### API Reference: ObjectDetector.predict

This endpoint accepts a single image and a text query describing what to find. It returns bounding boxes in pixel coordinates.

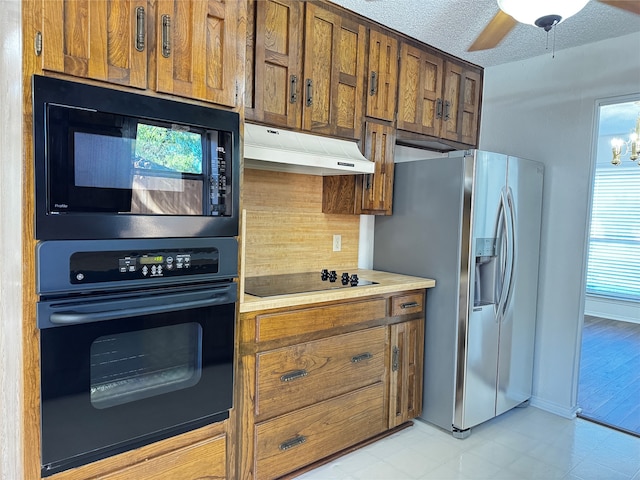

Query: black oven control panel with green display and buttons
[69,247,219,284]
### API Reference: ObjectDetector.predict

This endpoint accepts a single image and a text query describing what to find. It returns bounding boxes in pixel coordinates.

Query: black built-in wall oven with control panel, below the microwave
[37,238,238,476]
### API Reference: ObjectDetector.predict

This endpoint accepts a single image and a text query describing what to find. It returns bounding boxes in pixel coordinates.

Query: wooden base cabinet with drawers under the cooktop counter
[236,290,425,480]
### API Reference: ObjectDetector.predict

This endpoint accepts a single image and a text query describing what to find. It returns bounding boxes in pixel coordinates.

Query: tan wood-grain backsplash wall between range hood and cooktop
[241,169,360,276]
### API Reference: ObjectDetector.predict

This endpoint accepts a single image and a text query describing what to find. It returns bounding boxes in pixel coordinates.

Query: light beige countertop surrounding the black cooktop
[240,269,436,313]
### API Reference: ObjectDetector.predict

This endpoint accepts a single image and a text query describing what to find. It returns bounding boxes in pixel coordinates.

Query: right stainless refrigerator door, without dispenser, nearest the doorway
[496,157,543,415]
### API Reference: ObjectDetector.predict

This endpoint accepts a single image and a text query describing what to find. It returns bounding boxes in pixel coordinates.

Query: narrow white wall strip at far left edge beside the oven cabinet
[0,0,23,480]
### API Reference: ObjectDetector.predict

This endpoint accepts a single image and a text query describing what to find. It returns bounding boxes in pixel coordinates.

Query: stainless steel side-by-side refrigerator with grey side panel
[373,150,543,438]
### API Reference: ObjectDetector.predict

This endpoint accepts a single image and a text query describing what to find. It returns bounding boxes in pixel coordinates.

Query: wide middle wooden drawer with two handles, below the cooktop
[256,327,386,418]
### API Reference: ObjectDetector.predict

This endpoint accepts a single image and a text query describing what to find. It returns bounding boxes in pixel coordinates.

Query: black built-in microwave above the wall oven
[33,75,240,240]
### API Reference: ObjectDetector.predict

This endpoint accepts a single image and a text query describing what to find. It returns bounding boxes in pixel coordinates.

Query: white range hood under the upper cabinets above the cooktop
[244,123,374,175]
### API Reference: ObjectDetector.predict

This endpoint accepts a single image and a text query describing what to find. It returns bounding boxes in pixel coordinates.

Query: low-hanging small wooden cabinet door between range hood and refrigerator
[356,121,396,215]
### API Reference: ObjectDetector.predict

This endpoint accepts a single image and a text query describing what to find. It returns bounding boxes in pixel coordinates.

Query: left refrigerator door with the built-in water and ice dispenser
[454,151,507,430]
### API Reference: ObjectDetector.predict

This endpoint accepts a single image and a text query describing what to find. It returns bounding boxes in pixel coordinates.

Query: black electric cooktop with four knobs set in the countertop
[244,270,377,297]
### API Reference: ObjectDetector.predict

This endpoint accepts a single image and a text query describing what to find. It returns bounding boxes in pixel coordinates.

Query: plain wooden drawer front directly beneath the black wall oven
[100,434,227,480]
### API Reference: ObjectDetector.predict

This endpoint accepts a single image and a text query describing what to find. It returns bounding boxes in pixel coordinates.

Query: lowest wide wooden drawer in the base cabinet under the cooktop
[255,382,386,479]
